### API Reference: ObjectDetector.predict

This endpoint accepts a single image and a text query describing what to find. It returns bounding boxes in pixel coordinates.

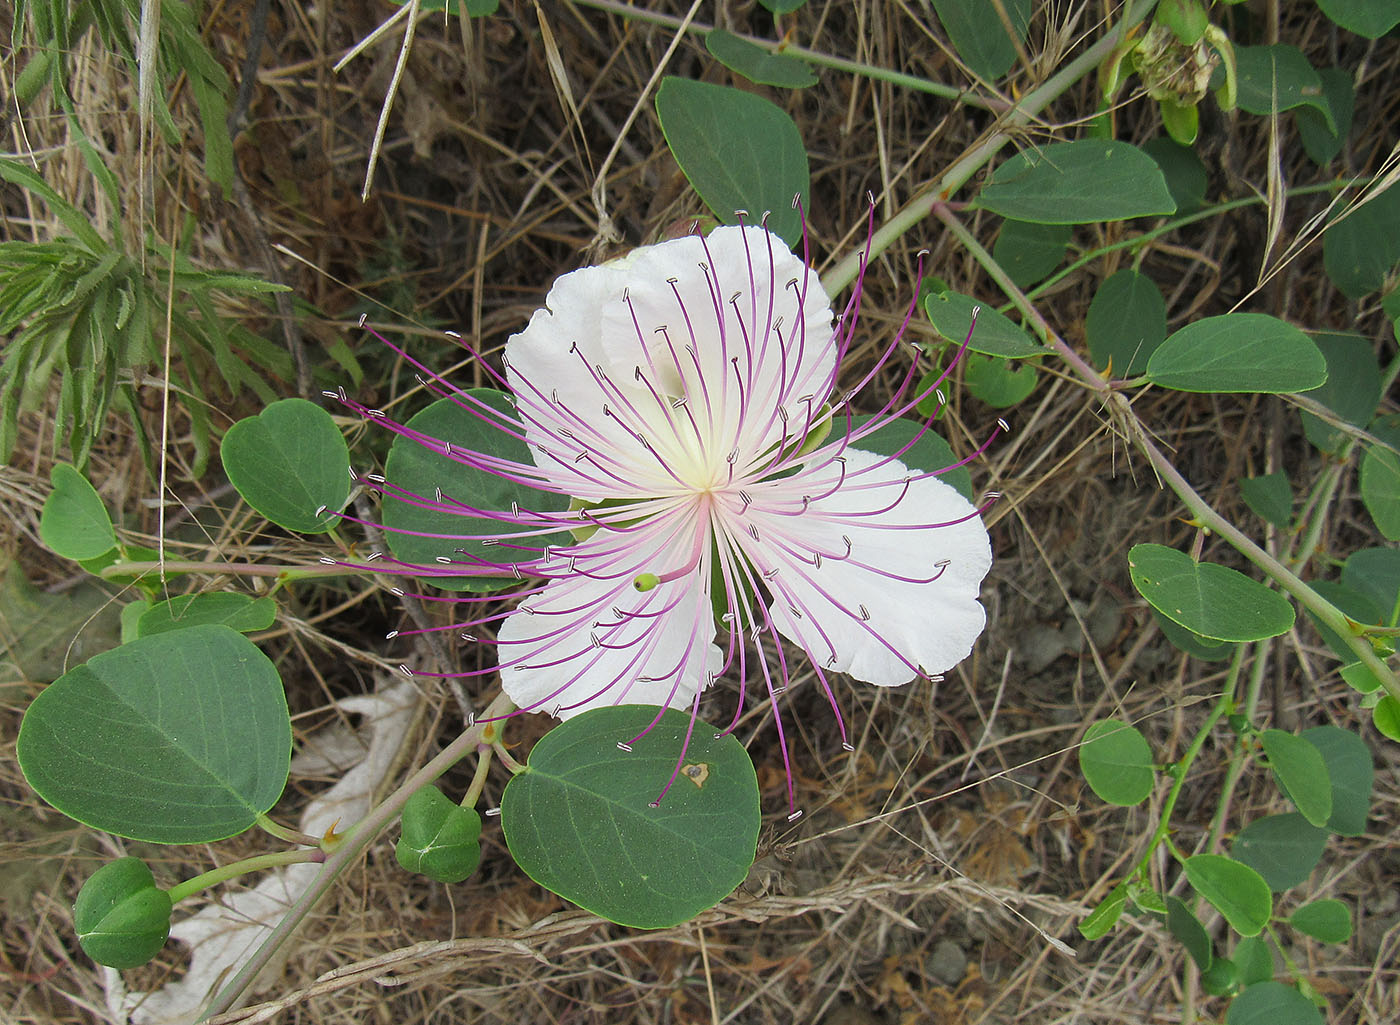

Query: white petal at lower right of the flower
[735,449,991,686]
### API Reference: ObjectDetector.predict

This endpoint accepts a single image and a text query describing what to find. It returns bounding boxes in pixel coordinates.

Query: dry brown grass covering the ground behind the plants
[0,0,1400,1025]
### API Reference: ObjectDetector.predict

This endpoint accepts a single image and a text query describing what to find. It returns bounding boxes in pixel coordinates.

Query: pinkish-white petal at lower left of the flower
[497,509,722,718]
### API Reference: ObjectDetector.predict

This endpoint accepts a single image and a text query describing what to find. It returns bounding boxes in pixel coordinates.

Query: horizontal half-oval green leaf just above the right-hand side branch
[1147,314,1327,395]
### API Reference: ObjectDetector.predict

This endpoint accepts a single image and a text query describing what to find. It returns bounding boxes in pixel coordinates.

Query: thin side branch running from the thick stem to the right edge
[930,203,1400,702]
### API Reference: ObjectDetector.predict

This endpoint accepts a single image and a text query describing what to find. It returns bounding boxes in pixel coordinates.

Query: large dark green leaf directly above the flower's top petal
[657,76,811,245]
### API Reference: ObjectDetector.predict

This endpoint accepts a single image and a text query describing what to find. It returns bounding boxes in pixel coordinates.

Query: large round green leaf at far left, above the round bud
[17,626,291,843]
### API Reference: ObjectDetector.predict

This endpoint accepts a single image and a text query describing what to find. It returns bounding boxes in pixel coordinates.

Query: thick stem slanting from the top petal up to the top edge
[817,0,1156,295]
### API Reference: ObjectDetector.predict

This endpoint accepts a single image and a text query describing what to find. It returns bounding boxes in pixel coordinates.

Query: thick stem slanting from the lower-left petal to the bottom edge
[199,693,514,1021]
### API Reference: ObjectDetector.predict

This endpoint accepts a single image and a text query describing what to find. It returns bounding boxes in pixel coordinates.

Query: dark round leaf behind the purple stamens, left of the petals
[382,388,573,591]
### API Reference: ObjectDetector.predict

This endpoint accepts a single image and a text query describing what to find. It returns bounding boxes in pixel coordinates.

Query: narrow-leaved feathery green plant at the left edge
[0,160,291,476]
